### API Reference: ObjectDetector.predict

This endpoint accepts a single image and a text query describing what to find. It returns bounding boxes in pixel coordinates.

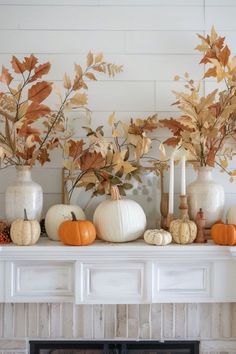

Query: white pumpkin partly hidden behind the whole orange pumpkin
[45,204,86,241]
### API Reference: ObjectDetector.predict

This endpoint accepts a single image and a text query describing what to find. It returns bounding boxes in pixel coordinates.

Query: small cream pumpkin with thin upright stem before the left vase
[10,209,41,246]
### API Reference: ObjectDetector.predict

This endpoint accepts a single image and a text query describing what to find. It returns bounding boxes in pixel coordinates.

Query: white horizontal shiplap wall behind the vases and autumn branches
[0,0,236,220]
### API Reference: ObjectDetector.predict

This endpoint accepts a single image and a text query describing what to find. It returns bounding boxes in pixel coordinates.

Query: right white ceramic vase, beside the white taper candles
[187,167,225,228]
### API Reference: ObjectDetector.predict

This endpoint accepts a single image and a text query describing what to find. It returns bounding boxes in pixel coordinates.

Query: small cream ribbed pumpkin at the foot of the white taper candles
[170,219,197,244]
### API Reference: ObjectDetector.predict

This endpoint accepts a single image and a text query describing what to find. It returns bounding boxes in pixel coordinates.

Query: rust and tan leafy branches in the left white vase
[0,52,122,166]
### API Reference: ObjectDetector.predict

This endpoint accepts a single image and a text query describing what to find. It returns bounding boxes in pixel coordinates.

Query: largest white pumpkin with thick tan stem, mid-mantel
[93,186,147,242]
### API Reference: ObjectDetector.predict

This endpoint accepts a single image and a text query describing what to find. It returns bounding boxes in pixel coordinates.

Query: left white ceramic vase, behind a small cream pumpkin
[5,166,43,223]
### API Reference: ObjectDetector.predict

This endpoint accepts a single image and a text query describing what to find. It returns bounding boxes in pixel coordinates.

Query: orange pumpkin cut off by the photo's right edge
[211,223,236,246]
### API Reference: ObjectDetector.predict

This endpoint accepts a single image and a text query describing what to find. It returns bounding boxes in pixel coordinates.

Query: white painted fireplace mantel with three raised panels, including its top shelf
[0,238,236,304]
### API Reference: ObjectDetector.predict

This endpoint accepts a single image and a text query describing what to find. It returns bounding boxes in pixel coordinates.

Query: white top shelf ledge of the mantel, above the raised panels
[0,237,233,261]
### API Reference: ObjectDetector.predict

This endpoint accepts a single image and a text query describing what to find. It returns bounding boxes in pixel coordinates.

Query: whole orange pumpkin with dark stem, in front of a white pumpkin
[58,212,96,246]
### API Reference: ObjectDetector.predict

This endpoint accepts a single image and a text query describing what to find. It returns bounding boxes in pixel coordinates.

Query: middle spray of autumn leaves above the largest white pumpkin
[64,113,167,200]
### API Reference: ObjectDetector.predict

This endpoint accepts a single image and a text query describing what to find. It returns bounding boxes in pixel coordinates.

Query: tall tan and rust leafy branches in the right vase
[161,27,236,180]
